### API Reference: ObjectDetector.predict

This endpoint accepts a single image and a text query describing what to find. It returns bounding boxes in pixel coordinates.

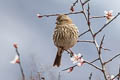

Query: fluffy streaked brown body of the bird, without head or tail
[53,24,78,50]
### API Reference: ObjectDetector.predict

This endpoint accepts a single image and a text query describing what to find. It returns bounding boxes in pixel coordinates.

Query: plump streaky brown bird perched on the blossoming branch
[53,14,79,67]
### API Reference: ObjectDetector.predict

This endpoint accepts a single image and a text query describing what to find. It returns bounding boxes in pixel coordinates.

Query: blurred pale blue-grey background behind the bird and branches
[0,0,120,80]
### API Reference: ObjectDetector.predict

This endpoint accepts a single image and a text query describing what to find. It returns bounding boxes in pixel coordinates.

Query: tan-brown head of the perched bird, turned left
[56,14,72,25]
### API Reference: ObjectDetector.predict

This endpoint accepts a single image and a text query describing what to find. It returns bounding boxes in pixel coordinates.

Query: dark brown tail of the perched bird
[53,48,64,67]
